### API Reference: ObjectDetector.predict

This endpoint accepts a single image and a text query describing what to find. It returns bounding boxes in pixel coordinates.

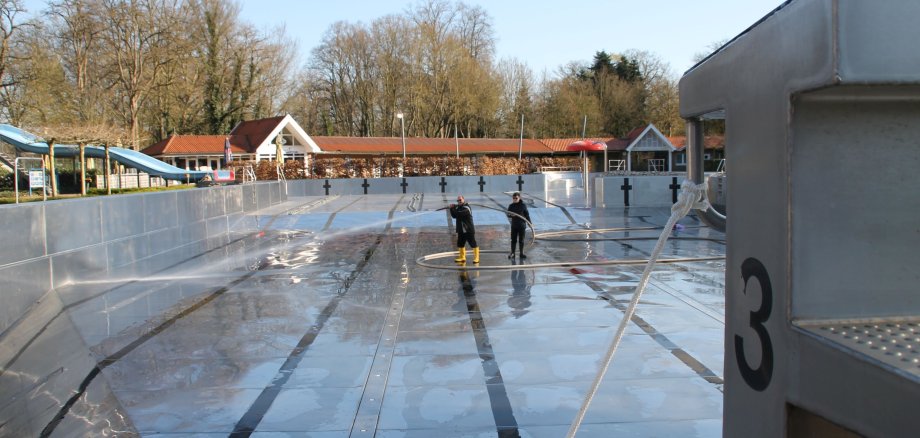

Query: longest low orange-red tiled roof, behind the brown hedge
[312,137,553,155]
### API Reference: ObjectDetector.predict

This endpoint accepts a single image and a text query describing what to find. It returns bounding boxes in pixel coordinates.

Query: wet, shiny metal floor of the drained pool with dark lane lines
[19,193,725,437]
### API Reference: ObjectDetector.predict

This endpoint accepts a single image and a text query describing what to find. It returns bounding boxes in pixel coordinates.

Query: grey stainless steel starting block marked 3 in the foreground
[680,0,920,437]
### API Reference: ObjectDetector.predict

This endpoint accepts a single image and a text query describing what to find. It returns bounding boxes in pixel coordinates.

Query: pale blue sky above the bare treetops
[242,0,783,78]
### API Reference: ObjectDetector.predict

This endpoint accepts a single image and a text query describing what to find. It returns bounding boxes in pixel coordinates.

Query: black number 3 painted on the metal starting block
[735,258,773,391]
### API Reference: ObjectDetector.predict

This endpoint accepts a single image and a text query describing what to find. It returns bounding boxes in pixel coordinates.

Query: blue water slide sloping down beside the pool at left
[0,124,210,181]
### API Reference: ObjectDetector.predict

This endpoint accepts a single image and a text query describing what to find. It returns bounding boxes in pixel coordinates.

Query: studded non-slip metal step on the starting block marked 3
[799,321,920,379]
